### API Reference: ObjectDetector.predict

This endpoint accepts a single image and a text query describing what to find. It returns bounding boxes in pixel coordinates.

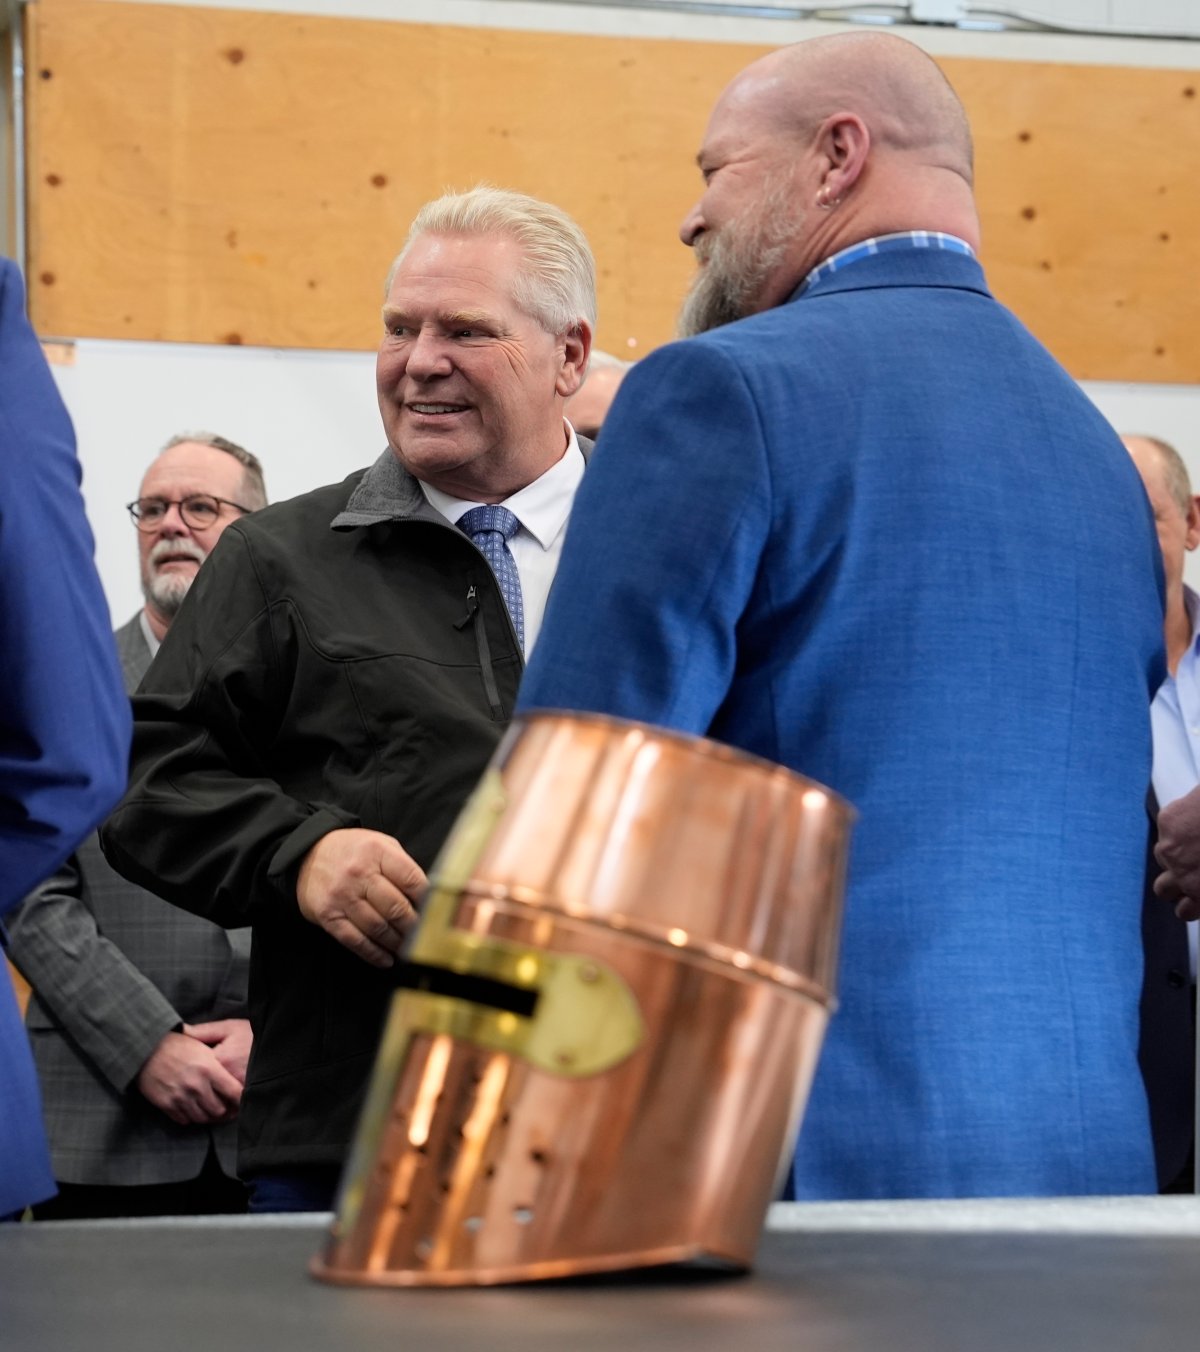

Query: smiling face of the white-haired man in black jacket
[376,234,588,503]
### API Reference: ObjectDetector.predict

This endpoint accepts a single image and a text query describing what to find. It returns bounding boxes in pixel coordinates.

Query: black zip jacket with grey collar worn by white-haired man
[103,452,523,1174]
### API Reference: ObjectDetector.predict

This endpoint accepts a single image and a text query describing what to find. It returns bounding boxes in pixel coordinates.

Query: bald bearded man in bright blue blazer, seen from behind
[520,32,1164,1198]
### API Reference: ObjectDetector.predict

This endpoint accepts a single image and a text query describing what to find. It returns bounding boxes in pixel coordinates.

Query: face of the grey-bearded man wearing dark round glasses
[138,441,246,638]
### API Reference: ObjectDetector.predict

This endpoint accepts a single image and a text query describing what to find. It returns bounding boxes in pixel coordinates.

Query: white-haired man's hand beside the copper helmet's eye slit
[296,826,427,967]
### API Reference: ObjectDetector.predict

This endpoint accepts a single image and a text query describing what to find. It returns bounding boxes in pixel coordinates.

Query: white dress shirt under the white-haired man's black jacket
[418,420,584,660]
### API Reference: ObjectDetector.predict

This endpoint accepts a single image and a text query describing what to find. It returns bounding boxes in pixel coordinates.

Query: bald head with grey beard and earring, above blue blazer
[680,32,978,334]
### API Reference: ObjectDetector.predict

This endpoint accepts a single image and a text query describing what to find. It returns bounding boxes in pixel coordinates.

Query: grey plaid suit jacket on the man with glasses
[9,617,250,1186]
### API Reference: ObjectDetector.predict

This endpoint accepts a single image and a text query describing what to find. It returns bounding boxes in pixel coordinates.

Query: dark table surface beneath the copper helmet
[0,1197,1200,1352]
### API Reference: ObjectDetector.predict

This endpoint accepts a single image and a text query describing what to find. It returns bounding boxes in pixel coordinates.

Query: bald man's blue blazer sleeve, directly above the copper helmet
[518,343,770,733]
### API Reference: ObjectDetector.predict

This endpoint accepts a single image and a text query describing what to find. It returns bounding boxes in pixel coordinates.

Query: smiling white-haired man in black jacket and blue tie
[104,188,596,1211]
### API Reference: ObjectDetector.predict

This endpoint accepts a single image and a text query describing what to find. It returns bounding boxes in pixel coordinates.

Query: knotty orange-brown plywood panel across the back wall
[27,0,1200,383]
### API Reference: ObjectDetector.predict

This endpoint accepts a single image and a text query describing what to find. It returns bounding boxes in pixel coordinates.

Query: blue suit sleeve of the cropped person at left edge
[0,260,130,914]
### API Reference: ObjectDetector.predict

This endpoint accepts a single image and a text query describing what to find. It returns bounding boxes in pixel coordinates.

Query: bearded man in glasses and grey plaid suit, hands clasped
[9,433,266,1220]
